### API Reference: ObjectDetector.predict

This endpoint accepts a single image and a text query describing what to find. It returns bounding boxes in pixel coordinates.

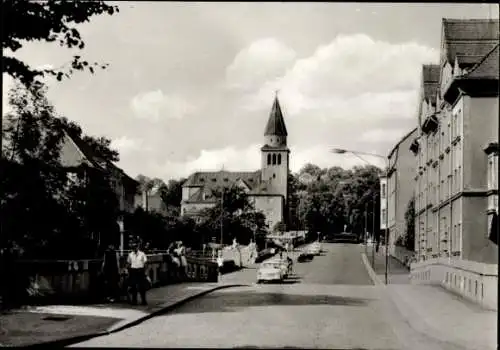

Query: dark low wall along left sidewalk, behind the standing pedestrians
[15,254,217,302]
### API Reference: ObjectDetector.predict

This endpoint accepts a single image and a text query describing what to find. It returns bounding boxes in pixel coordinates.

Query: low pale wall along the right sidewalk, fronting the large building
[410,258,498,310]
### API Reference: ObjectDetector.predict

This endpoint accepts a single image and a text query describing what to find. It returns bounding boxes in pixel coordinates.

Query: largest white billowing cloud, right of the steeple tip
[232,34,438,122]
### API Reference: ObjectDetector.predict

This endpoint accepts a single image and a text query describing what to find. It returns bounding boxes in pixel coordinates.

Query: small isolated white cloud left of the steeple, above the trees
[130,90,195,122]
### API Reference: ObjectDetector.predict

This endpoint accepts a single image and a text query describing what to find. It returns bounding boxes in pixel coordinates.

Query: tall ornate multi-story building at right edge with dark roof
[412,19,499,308]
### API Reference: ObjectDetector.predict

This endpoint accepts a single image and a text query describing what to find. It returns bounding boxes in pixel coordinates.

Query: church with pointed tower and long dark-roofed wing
[181,96,290,230]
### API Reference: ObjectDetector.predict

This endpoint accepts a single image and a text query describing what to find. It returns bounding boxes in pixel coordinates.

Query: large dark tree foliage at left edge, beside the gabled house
[0,84,122,258]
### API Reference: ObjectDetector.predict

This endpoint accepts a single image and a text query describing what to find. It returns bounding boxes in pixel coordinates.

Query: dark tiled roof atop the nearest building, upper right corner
[443,18,499,66]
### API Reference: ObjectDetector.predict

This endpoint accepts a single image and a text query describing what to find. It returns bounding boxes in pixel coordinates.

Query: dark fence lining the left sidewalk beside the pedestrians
[2,254,217,303]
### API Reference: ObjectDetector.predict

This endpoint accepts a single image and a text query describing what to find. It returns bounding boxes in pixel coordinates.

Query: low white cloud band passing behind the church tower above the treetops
[151,144,384,179]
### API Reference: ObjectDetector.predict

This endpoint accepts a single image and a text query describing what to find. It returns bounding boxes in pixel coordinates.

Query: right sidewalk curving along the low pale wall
[367,249,497,350]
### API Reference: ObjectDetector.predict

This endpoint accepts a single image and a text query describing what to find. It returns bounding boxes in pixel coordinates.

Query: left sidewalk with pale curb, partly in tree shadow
[0,283,240,346]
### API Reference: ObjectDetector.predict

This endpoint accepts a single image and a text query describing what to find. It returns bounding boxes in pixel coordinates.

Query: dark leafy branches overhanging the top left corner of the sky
[2,0,118,86]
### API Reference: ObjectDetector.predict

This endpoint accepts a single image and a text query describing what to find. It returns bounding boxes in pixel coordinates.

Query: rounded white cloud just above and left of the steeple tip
[226,38,296,90]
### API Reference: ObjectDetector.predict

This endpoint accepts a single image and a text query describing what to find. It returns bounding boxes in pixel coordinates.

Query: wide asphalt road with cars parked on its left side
[72,244,462,350]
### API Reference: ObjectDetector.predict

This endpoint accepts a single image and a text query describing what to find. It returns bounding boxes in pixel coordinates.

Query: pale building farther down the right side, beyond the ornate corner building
[381,128,417,253]
